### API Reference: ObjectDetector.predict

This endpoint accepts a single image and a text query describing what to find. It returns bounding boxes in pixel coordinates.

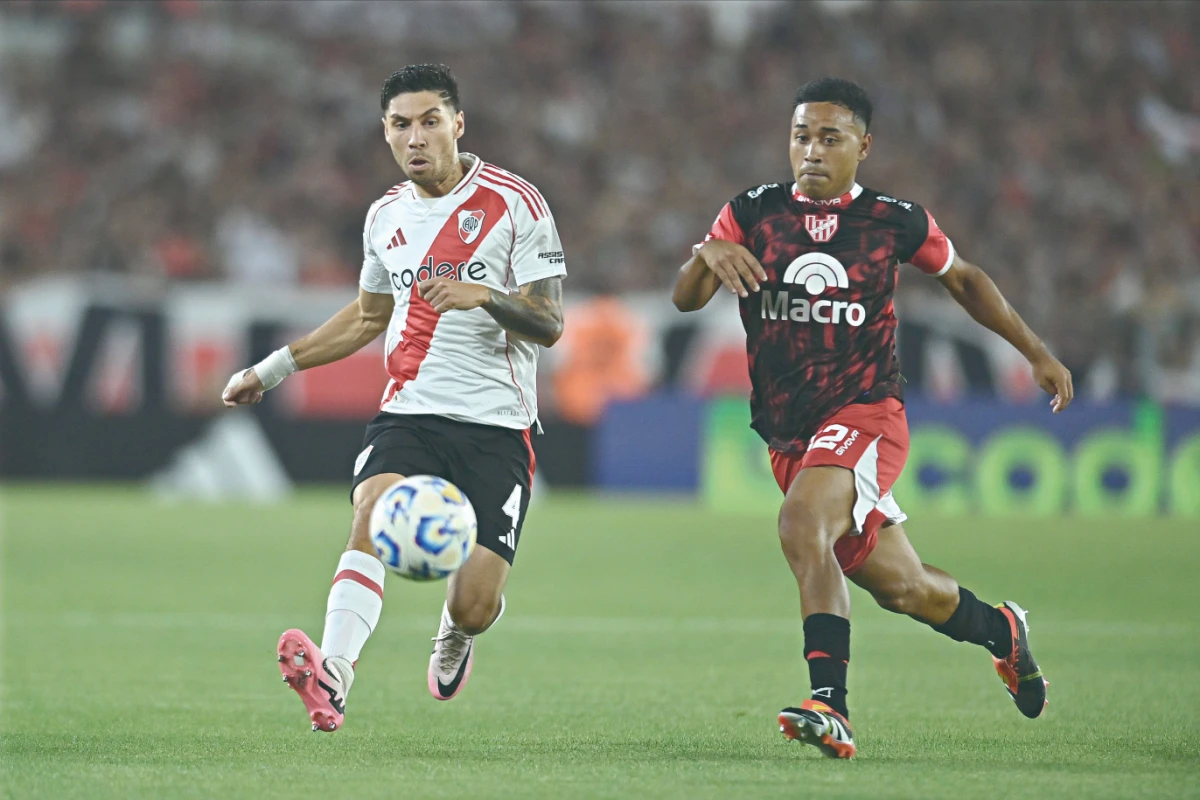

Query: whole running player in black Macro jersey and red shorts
[674,78,1074,758]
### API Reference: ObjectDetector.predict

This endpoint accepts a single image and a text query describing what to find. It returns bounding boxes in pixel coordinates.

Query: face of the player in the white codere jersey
[383,91,463,186]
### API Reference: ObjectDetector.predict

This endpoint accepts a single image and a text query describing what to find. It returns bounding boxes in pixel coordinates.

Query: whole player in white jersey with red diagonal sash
[222,65,566,730]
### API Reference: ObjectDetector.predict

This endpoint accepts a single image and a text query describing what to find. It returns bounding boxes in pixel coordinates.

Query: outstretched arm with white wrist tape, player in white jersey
[221,288,395,408]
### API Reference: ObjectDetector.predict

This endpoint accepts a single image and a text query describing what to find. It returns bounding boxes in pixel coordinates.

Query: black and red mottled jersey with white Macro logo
[704,181,954,452]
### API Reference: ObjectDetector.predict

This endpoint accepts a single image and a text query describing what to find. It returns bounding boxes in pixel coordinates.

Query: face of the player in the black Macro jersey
[790,103,871,200]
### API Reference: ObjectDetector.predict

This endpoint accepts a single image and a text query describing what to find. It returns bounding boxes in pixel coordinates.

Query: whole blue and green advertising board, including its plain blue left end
[593,395,1200,518]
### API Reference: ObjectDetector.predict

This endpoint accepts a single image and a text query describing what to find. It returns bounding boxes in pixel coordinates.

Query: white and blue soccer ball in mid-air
[371,475,476,581]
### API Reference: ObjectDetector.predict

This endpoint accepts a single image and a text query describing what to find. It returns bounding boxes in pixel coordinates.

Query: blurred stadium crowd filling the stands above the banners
[0,0,1200,402]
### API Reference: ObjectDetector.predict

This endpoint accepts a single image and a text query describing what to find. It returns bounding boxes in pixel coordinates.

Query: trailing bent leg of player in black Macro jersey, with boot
[851,524,1048,718]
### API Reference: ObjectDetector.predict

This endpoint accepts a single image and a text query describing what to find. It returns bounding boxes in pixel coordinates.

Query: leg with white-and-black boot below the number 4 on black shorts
[428,546,511,700]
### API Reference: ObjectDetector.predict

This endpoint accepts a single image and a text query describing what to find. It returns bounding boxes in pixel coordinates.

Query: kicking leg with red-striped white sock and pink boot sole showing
[277,473,401,732]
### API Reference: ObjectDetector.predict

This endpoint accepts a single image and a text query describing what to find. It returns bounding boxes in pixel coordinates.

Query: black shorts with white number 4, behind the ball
[350,411,538,564]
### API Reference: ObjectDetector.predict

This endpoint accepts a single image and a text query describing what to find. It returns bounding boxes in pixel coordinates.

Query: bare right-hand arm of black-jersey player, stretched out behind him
[938,255,1075,414]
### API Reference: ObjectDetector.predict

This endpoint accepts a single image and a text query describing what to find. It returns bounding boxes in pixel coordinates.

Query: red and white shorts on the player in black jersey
[770,397,908,575]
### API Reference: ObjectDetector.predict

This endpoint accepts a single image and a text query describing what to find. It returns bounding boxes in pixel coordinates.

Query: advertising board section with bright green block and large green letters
[702,399,1200,517]
